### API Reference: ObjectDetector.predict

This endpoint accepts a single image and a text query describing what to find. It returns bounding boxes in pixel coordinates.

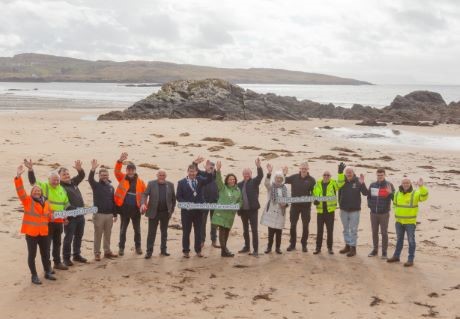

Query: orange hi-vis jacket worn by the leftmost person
[14,177,51,237]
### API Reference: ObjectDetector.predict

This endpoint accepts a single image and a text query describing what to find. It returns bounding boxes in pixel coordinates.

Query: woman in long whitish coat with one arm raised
[260,163,288,254]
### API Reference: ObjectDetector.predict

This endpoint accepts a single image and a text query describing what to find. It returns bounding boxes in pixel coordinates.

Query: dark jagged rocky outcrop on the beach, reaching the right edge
[98,79,460,125]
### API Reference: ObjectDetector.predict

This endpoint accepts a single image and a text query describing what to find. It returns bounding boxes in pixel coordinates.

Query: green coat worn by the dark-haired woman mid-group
[211,172,243,229]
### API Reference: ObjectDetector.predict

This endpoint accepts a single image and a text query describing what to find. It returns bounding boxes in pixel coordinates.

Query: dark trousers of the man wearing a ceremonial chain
[181,209,203,253]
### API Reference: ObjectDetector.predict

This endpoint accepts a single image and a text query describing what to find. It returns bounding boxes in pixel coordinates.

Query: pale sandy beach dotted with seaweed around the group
[0,110,460,318]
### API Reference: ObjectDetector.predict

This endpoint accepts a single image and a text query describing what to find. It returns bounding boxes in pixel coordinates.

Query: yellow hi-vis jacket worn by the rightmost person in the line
[393,186,428,224]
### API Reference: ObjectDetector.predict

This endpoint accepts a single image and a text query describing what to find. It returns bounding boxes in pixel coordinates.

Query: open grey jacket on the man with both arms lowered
[141,180,176,218]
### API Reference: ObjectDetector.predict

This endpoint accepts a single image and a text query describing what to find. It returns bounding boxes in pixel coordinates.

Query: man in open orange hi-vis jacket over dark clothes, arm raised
[114,152,145,256]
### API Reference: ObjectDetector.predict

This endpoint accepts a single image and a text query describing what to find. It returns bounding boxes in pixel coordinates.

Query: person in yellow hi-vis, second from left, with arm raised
[24,159,69,270]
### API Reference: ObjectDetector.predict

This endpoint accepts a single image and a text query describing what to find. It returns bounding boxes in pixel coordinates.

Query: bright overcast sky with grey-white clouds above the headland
[0,0,460,84]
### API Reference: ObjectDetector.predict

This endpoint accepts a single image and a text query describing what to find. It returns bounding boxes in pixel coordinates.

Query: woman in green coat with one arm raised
[212,161,243,257]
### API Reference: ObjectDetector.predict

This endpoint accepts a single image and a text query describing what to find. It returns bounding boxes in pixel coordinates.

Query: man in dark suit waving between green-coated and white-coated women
[238,158,264,257]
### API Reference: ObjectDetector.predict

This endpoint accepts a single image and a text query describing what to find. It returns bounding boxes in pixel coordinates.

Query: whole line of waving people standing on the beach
[14,153,428,284]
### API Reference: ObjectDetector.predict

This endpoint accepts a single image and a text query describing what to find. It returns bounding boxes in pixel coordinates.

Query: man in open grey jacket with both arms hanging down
[141,169,176,259]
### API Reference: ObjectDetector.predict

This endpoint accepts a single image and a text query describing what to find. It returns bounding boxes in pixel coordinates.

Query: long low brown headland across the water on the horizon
[0,53,371,85]
